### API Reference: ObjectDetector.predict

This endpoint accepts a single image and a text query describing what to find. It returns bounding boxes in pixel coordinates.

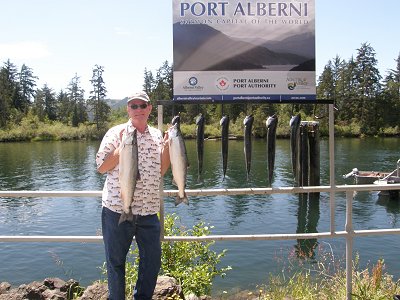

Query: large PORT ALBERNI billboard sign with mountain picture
[173,0,316,102]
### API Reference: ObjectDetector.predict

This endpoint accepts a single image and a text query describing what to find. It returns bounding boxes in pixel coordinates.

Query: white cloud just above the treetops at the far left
[0,42,51,60]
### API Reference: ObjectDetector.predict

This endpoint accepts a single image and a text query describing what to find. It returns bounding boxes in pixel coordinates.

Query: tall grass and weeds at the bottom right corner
[258,249,400,300]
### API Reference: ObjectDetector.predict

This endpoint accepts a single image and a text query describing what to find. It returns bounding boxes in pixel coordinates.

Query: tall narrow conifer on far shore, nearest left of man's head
[89,65,111,129]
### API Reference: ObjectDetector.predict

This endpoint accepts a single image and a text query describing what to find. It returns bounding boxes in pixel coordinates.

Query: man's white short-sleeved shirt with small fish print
[96,120,163,216]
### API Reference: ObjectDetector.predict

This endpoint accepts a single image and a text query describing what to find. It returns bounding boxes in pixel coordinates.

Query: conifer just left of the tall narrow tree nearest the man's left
[67,74,88,127]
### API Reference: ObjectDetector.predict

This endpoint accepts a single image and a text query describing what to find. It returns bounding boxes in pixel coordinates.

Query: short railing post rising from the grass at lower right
[346,191,354,300]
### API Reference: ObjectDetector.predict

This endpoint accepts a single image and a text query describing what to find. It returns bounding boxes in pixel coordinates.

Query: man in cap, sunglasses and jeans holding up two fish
[96,92,170,300]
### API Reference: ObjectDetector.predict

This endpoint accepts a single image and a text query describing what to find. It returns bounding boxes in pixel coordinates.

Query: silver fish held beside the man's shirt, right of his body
[168,124,189,205]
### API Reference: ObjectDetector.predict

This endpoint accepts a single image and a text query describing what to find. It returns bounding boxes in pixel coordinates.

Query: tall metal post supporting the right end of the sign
[329,104,335,234]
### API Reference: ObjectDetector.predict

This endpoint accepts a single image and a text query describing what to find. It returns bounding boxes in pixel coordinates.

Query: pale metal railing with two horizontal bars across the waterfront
[0,105,400,300]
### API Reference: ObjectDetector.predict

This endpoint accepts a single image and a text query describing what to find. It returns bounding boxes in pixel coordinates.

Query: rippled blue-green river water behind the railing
[0,138,400,293]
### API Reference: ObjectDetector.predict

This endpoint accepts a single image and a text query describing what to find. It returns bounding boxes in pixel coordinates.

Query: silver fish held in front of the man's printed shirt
[118,129,140,225]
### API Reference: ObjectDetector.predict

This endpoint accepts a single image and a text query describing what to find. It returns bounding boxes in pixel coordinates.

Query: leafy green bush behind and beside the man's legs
[102,214,231,297]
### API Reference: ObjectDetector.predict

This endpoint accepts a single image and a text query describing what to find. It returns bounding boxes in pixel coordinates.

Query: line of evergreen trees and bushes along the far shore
[0,43,400,140]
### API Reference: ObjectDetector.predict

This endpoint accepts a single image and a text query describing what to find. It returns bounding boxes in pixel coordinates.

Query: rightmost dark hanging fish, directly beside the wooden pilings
[289,114,301,186]
